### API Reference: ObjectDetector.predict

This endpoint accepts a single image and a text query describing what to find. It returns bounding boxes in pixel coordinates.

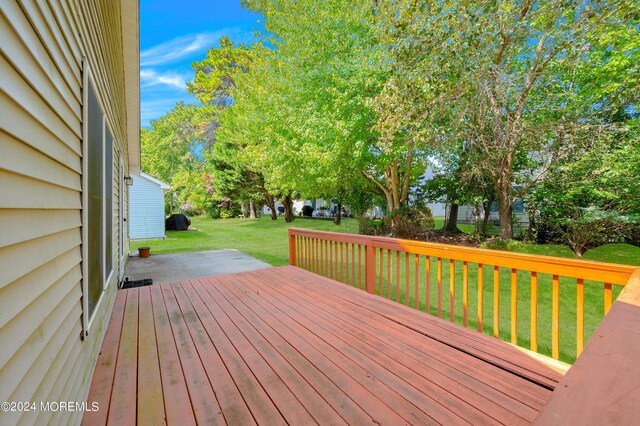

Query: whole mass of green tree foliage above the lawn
[143,0,640,246]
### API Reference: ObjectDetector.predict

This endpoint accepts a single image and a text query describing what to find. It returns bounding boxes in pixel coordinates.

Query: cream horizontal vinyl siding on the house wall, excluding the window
[0,0,131,425]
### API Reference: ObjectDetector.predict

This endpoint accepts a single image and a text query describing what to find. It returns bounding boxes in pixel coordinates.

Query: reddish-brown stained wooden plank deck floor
[83,266,562,425]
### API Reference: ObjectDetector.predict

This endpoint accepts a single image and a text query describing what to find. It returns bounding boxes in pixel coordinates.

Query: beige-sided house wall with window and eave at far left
[0,0,140,424]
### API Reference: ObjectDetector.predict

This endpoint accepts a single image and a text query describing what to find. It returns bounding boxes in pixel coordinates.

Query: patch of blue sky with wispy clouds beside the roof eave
[140,0,261,127]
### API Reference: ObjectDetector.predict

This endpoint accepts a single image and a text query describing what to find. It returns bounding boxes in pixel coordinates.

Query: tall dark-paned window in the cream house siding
[82,68,114,335]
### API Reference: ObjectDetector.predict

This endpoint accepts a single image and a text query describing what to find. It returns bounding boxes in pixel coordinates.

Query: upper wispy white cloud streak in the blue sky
[140,28,253,67]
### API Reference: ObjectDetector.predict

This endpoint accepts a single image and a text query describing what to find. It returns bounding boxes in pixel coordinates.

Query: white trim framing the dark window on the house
[81,58,115,339]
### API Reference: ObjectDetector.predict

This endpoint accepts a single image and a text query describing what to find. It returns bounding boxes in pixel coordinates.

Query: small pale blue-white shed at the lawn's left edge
[129,173,171,240]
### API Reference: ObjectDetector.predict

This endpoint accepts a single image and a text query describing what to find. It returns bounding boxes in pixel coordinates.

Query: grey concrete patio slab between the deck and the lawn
[124,250,271,284]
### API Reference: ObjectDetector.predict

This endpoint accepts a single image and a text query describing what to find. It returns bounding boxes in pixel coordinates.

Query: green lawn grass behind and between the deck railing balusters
[131,217,640,362]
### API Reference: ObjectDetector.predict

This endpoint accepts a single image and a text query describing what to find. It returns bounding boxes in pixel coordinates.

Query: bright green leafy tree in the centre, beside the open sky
[235,0,440,216]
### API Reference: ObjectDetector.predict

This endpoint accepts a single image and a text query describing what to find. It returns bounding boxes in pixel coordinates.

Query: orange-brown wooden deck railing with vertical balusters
[289,228,636,362]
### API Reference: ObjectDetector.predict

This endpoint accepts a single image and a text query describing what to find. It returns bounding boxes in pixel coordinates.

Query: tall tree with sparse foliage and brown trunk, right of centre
[370,0,638,238]
